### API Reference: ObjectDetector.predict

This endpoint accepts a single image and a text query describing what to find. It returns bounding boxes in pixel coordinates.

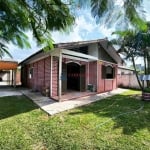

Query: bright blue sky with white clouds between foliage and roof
[5,0,150,63]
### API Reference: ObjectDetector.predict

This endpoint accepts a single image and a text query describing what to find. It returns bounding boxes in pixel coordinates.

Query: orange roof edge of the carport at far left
[0,60,18,70]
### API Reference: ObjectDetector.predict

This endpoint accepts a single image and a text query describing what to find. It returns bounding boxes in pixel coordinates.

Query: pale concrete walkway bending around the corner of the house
[22,88,127,115]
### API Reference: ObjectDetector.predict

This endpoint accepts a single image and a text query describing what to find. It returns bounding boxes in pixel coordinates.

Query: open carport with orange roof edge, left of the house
[0,60,18,87]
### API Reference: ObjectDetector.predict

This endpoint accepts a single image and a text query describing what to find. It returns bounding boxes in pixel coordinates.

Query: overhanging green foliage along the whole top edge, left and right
[0,0,147,57]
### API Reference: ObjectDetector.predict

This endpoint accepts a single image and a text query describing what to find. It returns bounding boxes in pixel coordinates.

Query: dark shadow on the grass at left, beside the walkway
[0,96,38,120]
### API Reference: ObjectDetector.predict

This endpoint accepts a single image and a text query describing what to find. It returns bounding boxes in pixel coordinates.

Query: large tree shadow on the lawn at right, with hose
[69,95,150,135]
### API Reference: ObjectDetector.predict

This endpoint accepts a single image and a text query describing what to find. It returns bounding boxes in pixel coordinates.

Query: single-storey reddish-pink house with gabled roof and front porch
[20,39,122,101]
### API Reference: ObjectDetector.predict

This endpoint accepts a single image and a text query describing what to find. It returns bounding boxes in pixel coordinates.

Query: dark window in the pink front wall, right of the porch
[102,65,115,79]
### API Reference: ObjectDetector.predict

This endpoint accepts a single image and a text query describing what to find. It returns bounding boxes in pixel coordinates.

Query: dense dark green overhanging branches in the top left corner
[0,0,74,57]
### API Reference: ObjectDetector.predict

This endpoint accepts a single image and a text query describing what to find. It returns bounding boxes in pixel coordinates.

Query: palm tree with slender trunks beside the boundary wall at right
[112,23,150,89]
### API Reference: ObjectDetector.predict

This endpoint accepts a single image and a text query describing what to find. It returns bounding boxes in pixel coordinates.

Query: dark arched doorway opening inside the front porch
[67,62,80,91]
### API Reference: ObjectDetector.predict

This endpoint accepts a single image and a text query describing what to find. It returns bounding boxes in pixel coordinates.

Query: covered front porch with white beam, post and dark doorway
[50,49,98,101]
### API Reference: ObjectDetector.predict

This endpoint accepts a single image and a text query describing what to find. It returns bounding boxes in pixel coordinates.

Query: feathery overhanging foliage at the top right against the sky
[78,0,147,30]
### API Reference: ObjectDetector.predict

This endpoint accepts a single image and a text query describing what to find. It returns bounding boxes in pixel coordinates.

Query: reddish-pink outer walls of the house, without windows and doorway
[22,56,117,97]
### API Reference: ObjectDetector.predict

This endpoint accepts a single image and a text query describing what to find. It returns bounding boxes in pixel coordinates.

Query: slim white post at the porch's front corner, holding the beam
[58,51,62,102]
